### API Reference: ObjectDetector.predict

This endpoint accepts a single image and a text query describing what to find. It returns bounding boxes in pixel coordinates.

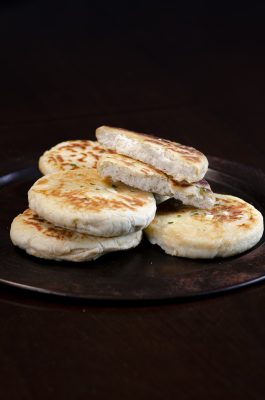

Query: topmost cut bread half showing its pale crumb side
[96,126,208,183]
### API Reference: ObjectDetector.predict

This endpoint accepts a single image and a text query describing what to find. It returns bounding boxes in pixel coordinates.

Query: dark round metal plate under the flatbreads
[0,157,265,300]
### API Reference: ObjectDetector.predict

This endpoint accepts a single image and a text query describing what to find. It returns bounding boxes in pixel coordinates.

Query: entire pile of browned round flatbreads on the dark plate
[11,126,263,261]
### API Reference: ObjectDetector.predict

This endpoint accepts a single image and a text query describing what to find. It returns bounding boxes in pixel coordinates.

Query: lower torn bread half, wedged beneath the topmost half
[97,153,215,209]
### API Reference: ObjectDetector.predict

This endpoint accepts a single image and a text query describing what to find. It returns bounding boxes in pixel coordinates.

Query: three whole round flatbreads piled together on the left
[11,140,156,261]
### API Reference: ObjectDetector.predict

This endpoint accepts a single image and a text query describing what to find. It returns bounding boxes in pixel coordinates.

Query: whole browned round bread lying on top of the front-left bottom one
[28,169,156,237]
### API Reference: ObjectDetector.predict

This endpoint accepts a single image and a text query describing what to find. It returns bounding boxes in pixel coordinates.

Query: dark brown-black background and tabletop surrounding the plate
[0,1,265,400]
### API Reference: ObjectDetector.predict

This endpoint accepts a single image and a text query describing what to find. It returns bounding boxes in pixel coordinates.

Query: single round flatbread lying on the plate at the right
[145,194,263,258]
